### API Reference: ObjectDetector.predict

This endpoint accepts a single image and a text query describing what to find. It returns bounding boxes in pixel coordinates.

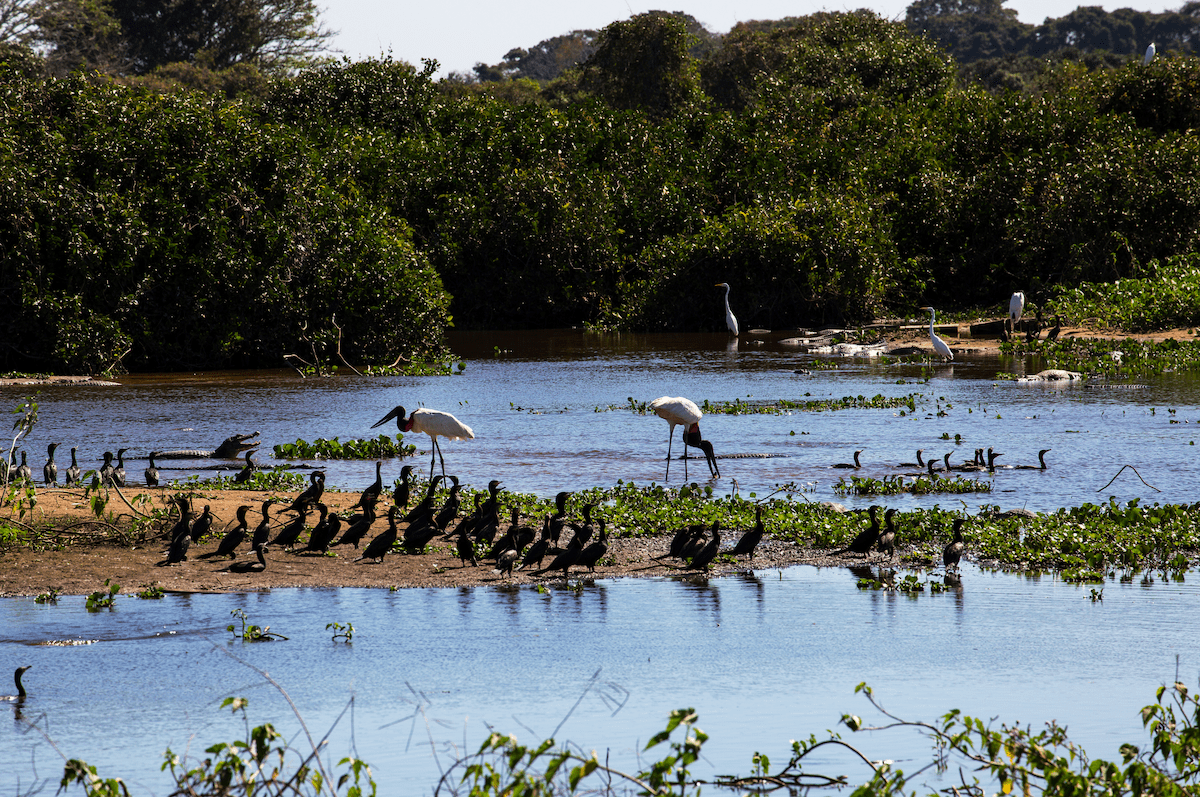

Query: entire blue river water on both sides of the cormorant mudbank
[0,331,1200,795]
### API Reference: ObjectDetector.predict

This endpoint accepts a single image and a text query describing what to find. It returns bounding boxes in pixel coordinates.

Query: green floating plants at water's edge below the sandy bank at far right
[1000,337,1200,378]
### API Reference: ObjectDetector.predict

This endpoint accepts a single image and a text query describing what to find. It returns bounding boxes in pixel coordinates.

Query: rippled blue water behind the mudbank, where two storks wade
[0,330,1200,510]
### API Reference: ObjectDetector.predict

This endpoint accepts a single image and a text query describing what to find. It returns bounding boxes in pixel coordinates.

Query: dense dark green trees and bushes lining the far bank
[0,0,1200,372]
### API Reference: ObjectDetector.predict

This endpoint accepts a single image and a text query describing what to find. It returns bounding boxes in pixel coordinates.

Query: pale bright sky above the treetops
[318,0,1184,76]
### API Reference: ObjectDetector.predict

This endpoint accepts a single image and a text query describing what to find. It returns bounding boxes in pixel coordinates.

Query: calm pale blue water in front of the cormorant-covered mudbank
[0,568,1200,793]
